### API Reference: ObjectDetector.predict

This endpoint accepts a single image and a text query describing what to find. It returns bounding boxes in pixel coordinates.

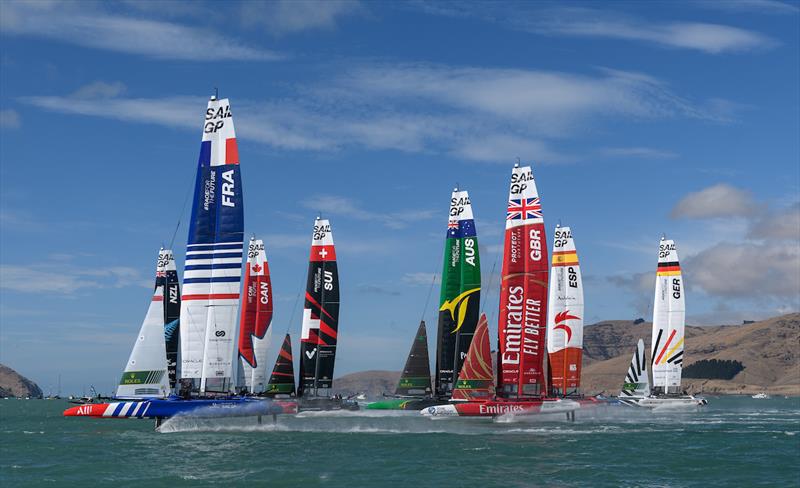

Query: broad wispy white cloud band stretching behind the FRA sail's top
[21,64,728,163]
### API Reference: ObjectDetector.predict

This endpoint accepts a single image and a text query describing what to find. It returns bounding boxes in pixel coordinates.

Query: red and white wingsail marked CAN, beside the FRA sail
[239,239,272,393]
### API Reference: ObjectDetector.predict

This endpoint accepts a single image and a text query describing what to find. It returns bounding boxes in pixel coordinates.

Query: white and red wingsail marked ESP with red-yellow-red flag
[547,225,583,396]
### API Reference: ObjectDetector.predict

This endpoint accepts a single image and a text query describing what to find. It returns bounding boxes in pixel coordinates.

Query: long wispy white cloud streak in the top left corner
[0,1,281,61]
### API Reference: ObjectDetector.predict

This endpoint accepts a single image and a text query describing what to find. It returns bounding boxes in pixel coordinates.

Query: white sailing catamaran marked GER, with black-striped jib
[620,237,708,408]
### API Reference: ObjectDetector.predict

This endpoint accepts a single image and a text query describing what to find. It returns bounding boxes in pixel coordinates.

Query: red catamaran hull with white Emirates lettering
[419,398,581,417]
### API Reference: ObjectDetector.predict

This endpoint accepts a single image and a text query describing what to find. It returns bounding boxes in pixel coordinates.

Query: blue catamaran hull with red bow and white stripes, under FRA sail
[64,398,296,419]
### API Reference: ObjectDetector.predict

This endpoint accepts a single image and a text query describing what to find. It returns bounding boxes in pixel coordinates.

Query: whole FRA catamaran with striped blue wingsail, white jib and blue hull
[64,96,284,425]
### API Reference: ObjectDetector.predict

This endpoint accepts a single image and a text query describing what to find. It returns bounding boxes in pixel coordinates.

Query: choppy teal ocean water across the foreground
[0,397,800,488]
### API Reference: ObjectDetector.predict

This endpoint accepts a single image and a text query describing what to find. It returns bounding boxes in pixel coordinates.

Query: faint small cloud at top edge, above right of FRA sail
[241,0,364,35]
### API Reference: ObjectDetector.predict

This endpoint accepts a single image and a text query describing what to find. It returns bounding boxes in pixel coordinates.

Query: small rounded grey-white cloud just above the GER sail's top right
[671,183,759,219]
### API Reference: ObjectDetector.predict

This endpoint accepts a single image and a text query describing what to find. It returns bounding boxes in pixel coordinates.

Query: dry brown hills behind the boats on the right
[334,313,800,397]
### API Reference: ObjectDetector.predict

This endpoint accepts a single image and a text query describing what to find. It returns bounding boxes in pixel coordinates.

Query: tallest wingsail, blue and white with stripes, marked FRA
[180,97,243,392]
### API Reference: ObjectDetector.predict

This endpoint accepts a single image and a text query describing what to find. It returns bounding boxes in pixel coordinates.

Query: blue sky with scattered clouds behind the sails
[0,0,800,393]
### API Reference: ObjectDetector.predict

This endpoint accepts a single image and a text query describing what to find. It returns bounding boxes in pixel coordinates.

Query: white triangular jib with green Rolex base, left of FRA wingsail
[117,252,169,398]
